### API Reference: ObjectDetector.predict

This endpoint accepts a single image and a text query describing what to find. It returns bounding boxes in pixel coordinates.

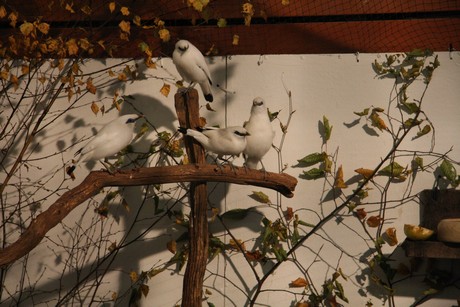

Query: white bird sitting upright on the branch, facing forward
[243,97,275,169]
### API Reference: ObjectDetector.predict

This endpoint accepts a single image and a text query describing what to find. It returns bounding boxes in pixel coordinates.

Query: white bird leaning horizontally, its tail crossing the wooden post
[179,126,249,159]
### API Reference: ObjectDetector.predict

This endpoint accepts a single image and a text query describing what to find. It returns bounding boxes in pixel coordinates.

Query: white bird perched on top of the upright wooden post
[172,40,213,102]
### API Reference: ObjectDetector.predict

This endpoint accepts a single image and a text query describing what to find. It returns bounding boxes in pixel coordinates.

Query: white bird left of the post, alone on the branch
[67,114,143,176]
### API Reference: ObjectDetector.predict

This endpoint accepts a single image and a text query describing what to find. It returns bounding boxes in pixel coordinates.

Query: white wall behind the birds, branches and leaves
[3,53,460,306]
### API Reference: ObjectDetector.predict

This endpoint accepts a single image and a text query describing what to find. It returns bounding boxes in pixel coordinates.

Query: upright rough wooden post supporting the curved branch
[174,89,208,307]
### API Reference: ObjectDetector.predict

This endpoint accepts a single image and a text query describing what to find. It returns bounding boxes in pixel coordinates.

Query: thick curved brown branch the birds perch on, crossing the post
[0,164,297,267]
